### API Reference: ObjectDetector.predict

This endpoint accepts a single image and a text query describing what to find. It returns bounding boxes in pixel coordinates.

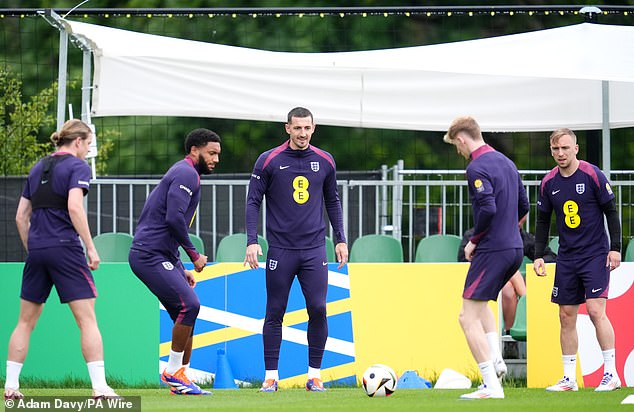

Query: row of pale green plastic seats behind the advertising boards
[93,233,634,266]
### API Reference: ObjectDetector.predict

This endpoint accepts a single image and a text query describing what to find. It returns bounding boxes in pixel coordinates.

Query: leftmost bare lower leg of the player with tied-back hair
[4,299,44,399]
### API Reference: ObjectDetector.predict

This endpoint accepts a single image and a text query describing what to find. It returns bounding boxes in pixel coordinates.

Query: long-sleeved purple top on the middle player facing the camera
[246,141,346,249]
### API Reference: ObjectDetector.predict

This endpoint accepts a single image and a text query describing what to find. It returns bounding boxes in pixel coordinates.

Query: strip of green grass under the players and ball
[12,388,634,412]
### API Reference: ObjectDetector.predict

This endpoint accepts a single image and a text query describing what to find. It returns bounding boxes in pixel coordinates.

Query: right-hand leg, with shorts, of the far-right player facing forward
[580,256,621,392]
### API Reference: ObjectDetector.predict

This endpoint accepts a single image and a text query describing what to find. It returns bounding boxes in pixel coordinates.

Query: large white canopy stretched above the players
[50,11,634,170]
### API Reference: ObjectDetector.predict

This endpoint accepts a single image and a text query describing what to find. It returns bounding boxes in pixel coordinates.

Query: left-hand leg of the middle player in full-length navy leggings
[260,247,298,392]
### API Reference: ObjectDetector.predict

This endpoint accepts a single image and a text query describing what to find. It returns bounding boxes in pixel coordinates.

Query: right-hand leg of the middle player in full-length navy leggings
[297,247,328,392]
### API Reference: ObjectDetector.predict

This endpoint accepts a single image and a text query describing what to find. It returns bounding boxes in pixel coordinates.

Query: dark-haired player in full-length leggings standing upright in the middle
[245,107,348,392]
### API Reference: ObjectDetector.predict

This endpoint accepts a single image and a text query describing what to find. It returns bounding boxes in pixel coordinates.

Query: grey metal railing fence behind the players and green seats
[0,169,634,261]
